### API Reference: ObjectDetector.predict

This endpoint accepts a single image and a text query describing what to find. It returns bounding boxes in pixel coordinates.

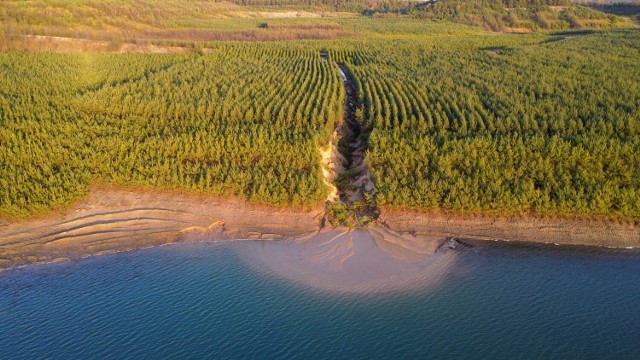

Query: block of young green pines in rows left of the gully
[0,45,344,216]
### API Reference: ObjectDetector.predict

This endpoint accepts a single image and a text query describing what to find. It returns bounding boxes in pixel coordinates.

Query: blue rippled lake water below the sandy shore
[0,239,640,359]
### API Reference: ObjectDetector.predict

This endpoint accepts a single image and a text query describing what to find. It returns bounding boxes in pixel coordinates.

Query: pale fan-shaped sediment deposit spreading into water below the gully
[238,226,457,294]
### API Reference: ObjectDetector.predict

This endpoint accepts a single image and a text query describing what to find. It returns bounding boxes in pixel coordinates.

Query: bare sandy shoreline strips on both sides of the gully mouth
[0,188,640,272]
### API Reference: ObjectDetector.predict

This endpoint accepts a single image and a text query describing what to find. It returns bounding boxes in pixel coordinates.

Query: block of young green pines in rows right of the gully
[332,31,640,219]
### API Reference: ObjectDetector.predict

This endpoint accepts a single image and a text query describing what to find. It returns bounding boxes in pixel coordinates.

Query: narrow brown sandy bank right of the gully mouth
[379,210,640,248]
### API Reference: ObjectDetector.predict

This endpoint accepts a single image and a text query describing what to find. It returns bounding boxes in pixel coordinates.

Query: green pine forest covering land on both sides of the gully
[0,1,640,221]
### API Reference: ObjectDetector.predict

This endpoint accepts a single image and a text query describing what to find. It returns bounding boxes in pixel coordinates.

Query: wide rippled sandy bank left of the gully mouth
[0,189,323,270]
